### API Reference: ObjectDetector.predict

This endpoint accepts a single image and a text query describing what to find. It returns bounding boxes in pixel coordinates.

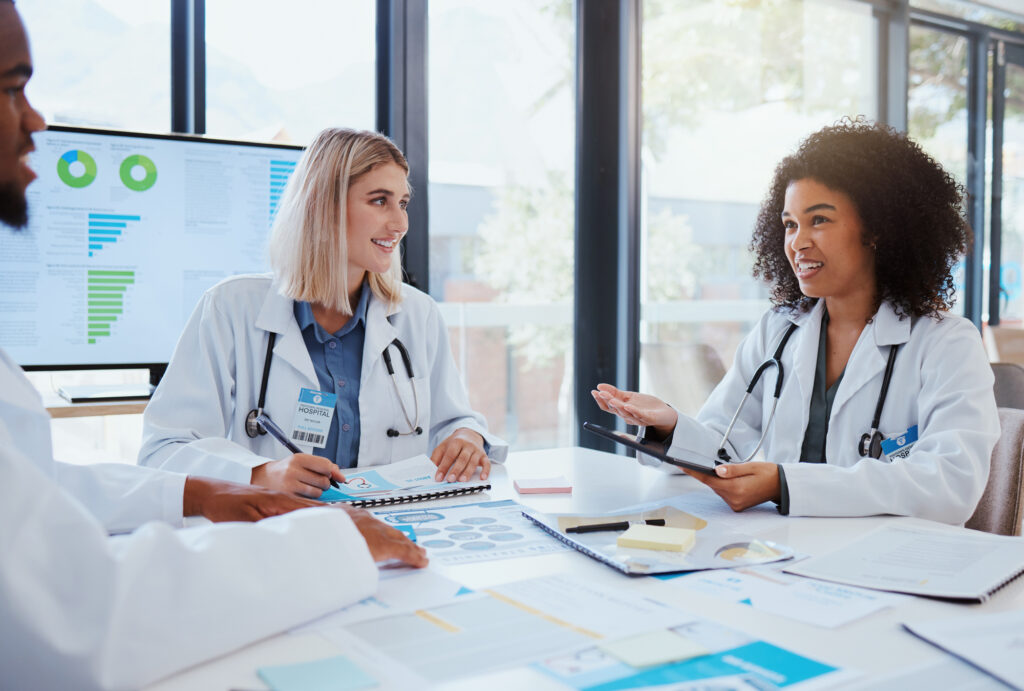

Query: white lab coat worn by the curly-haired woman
[669,300,999,524]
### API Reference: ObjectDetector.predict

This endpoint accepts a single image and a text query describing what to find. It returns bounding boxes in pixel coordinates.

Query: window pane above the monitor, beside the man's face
[17,0,171,132]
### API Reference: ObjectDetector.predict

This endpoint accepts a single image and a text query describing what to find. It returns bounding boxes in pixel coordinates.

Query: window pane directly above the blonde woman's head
[206,0,376,144]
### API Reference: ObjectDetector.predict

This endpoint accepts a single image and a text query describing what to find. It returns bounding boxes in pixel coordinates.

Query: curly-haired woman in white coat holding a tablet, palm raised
[593,121,999,523]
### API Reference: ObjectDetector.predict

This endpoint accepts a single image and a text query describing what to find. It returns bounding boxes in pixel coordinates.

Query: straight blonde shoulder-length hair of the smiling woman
[270,127,409,315]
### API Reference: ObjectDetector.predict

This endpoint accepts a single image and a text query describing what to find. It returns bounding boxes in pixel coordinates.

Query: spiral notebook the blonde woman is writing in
[319,455,490,507]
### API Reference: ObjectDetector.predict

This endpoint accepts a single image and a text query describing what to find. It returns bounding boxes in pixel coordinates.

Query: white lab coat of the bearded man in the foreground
[0,350,377,690]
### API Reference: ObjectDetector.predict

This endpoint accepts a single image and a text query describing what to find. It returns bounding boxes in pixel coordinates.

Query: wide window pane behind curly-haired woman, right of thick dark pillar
[640,0,878,413]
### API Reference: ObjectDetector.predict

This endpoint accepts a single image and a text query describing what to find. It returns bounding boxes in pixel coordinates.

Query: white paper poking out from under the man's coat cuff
[289,568,471,634]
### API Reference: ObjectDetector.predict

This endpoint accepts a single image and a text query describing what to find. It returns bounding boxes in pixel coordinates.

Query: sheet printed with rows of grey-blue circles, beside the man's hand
[374,500,569,564]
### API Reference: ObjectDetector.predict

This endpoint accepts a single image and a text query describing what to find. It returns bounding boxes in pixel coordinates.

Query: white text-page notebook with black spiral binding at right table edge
[785,520,1024,602]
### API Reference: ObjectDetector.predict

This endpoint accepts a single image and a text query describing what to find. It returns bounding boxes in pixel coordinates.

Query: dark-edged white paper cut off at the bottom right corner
[903,610,1024,689]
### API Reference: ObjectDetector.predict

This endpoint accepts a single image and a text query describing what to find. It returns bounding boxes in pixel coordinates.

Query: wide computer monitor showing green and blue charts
[0,127,302,380]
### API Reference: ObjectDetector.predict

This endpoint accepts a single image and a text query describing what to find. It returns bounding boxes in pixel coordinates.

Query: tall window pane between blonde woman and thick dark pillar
[425,0,574,448]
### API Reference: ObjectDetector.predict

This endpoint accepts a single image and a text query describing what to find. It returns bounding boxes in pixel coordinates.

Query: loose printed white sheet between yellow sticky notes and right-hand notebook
[667,562,905,629]
